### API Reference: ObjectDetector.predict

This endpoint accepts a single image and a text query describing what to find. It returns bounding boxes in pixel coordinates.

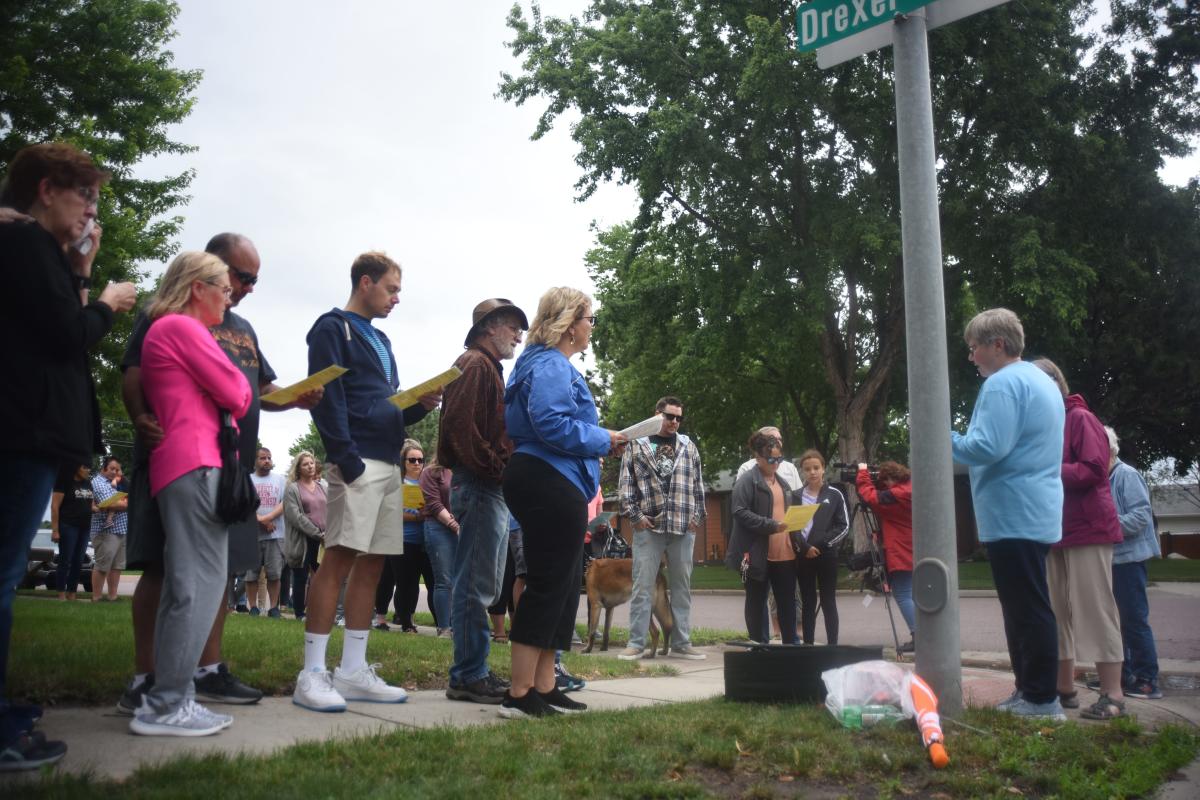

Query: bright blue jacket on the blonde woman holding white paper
[504,344,611,503]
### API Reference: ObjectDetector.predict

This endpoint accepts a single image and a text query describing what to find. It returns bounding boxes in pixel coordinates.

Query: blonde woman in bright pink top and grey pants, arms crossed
[130,253,251,736]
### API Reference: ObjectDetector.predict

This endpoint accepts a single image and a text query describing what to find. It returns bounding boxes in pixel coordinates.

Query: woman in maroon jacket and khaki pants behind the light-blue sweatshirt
[1033,359,1124,720]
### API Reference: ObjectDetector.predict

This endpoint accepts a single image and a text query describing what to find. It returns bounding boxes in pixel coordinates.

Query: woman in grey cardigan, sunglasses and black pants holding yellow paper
[726,432,796,644]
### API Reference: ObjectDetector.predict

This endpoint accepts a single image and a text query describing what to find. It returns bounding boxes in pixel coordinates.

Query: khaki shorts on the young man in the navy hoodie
[325,458,404,555]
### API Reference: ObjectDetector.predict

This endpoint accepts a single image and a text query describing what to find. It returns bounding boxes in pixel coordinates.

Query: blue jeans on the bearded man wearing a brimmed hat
[448,469,509,686]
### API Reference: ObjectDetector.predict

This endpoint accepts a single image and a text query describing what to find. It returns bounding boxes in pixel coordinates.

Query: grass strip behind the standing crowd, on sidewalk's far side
[8,593,674,705]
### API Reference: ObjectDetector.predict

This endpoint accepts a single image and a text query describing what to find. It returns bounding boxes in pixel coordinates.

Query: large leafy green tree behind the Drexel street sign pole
[500,0,1196,472]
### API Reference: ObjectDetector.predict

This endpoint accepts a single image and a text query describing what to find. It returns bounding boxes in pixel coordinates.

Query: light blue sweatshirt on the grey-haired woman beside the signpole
[950,361,1066,545]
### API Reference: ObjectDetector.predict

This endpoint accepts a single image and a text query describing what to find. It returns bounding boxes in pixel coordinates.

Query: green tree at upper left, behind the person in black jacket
[0,0,200,450]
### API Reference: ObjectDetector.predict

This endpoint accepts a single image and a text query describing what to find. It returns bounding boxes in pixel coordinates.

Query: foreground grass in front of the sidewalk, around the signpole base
[14,699,1198,800]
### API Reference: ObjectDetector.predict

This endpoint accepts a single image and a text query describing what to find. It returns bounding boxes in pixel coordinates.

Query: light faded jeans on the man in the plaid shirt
[629,529,696,650]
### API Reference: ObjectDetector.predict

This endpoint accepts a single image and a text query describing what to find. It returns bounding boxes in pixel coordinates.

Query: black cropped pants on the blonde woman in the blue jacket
[504,453,589,650]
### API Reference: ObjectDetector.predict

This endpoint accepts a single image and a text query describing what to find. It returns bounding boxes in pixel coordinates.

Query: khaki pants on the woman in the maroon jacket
[1046,545,1124,663]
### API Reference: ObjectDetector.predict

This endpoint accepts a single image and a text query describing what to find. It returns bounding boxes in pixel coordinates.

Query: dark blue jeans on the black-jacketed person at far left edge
[0,456,56,705]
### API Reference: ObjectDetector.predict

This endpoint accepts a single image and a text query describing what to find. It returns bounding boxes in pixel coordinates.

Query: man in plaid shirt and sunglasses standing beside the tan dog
[618,396,704,661]
